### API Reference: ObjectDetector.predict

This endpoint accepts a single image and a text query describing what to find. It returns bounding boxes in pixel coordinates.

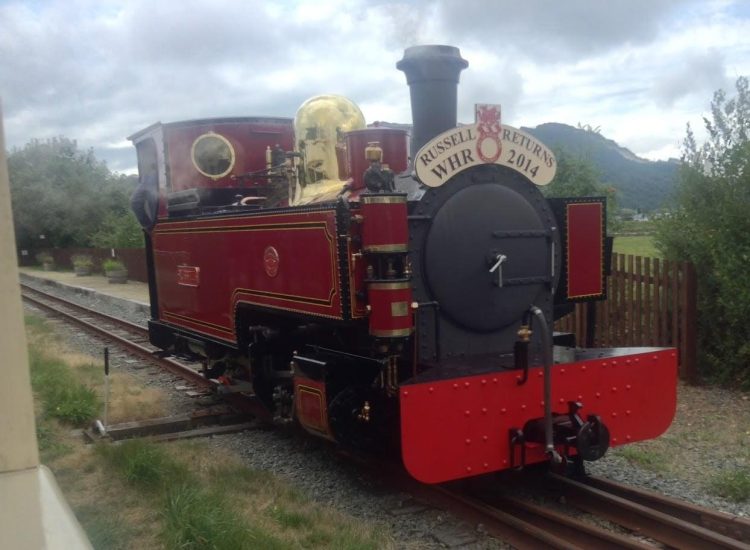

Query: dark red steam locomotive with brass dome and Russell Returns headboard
[129,46,677,483]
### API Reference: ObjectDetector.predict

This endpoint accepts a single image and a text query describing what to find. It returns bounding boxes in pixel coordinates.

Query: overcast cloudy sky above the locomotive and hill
[0,0,750,172]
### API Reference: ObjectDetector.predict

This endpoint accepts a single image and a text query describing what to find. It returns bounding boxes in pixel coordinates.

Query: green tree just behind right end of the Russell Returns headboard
[542,149,617,232]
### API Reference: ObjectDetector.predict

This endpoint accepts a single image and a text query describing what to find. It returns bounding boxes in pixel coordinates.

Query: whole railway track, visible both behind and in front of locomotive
[22,285,750,550]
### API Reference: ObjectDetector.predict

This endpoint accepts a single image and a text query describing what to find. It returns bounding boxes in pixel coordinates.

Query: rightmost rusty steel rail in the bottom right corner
[585,476,750,543]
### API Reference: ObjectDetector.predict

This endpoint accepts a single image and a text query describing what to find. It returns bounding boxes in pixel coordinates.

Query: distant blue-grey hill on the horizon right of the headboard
[522,122,679,212]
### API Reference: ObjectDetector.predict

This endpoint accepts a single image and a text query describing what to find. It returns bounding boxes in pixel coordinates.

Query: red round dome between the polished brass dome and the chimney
[346,128,408,189]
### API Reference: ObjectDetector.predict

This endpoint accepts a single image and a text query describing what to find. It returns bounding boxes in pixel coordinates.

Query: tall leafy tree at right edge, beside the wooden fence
[656,77,750,389]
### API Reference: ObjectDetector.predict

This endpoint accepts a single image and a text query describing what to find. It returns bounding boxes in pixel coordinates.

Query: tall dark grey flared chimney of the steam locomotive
[396,46,469,158]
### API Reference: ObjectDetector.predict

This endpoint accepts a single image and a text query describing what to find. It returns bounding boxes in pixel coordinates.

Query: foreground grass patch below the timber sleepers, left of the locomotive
[95,440,389,550]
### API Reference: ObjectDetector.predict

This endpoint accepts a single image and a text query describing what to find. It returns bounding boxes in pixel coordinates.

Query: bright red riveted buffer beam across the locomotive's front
[400,348,677,483]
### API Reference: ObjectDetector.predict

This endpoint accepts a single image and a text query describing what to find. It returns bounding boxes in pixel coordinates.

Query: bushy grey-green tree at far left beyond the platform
[8,137,140,249]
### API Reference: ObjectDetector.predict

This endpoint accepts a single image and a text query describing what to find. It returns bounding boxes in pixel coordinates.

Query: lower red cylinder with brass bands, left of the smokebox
[367,281,414,338]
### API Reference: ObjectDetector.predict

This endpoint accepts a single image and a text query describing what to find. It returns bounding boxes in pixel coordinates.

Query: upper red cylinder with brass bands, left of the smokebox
[359,193,409,253]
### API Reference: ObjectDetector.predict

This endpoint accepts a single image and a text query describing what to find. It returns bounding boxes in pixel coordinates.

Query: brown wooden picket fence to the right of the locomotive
[555,253,697,381]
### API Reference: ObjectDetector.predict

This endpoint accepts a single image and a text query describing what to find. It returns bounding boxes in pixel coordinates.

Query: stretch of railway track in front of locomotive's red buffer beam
[417,474,750,550]
